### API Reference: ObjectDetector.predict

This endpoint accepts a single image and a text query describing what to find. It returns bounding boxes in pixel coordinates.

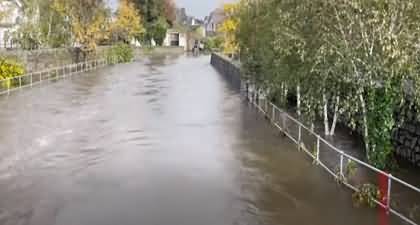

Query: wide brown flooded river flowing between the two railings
[0,55,377,225]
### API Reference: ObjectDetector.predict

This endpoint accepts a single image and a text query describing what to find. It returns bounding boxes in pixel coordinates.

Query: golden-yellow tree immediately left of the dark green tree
[111,0,144,43]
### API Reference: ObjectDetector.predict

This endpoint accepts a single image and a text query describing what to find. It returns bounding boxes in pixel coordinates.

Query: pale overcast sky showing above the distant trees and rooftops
[108,0,235,19]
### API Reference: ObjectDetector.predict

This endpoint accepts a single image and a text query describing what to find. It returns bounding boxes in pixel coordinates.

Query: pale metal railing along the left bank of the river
[0,59,115,95]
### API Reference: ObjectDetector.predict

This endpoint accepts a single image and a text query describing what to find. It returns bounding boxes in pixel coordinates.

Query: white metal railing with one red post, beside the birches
[246,84,420,225]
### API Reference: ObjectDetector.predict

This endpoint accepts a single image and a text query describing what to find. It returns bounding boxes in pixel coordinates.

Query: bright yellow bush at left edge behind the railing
[0,58,25,88]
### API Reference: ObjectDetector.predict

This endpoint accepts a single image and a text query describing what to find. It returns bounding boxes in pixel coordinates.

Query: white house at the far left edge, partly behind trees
[0,0,24,48]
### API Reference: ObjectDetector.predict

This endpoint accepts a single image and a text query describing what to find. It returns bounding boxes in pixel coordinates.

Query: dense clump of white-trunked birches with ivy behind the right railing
[232,0,420,168]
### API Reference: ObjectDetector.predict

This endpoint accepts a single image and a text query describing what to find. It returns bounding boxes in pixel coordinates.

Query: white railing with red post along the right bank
[246,84,420,225]
